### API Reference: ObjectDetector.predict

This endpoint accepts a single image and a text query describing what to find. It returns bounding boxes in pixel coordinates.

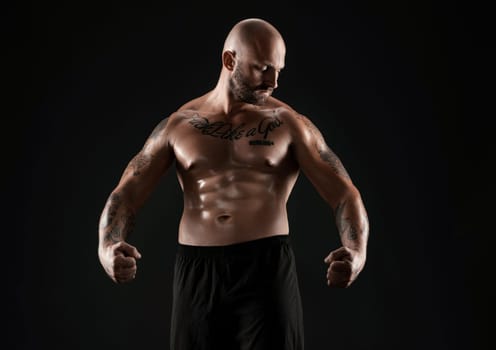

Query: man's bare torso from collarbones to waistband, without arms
[168,95,298,246]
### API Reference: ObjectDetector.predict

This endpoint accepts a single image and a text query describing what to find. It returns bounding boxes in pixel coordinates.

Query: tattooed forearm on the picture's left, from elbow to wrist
[99,191,135,249]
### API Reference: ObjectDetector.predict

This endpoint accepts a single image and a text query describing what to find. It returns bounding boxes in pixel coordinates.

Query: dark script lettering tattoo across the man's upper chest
[189,115,283,146]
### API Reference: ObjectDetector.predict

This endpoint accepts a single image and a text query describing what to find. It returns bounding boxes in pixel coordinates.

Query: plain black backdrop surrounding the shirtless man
[2,0,494,350]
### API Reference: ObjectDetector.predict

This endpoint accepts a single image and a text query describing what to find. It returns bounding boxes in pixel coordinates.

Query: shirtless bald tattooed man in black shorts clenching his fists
[98,18,368,350]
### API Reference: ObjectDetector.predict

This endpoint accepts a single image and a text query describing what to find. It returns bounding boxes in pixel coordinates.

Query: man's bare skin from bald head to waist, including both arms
[98,19,368,287]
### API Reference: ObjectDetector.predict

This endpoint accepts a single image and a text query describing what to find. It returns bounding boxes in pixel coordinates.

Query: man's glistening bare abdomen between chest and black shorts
[179,169,289,246]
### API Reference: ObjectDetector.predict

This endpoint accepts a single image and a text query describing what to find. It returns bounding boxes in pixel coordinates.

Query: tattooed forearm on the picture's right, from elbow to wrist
[334,189,369,256]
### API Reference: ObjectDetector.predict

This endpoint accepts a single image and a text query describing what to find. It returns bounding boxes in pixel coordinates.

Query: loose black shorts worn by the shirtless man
[171,235,303,350]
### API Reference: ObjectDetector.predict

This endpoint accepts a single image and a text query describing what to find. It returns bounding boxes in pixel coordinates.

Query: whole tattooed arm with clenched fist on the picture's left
[98,118,174,283]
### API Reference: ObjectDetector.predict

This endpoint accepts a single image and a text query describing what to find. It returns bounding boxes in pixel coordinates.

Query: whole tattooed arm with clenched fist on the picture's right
[286,115,369,288]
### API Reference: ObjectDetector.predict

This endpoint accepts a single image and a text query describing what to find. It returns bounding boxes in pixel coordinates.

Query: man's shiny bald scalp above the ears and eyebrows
[223,18,285,56]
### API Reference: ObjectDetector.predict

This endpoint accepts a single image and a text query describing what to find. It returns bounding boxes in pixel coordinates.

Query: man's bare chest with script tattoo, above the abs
[174,116,290,171]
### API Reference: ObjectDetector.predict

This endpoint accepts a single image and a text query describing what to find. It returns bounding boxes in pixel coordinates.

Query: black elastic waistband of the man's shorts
[177,234,290,257]
